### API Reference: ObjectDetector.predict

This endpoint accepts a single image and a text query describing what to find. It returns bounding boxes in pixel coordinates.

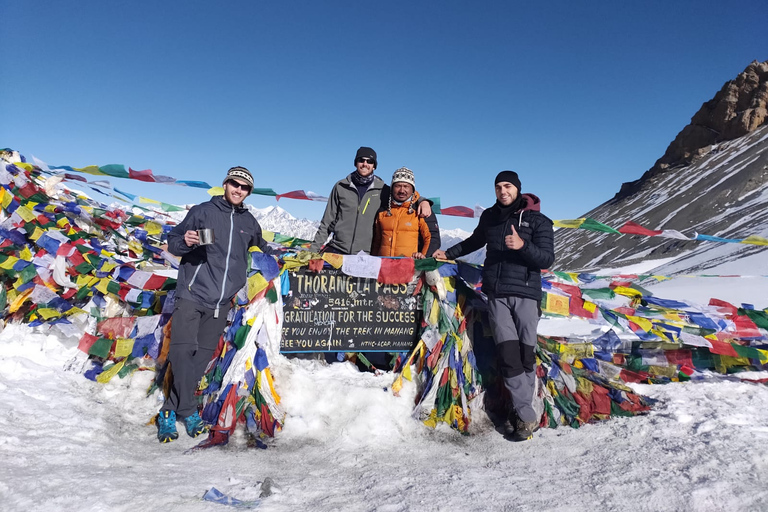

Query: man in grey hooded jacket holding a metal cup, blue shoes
[157,167,273,443]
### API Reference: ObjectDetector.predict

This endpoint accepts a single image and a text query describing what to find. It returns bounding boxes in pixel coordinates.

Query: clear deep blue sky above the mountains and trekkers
[0,0,768,230]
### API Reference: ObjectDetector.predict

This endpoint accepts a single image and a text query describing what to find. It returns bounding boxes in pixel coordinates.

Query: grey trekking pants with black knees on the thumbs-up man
[488,297,539,422]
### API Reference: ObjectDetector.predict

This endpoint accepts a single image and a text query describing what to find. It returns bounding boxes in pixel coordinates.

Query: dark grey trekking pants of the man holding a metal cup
[162,297,229,418]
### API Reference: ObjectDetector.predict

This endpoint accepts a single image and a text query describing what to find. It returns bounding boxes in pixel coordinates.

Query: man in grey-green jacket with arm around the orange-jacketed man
[309,146,432,254]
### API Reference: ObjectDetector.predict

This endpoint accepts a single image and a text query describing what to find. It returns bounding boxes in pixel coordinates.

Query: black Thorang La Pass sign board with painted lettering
[280,268,420,352]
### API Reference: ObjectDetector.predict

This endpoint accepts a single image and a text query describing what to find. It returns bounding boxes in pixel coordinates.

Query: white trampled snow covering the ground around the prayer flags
[0,269,768,512]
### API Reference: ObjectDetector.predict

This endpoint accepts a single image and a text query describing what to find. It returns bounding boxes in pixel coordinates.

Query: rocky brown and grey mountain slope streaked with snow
[555,62,768,273]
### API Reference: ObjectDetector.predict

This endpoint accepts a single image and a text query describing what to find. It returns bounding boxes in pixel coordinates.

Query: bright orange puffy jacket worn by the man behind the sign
[371,192,432,258]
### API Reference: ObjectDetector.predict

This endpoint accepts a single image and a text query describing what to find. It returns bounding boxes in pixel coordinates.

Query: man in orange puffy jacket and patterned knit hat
[371,167,432,259]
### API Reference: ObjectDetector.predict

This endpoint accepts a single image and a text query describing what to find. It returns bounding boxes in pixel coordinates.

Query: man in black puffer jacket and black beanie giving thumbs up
[433,171,555,441]
